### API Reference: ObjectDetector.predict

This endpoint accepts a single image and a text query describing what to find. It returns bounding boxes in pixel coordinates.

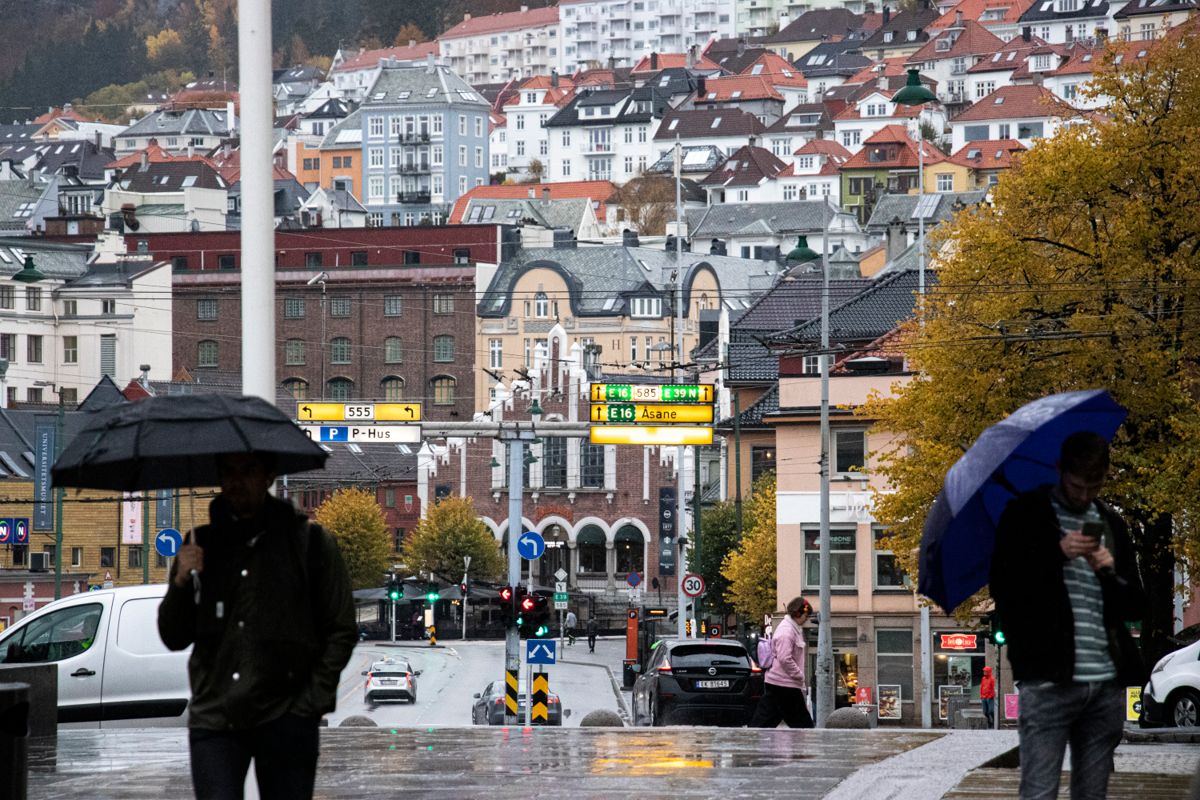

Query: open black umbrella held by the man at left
[52,395,329,492]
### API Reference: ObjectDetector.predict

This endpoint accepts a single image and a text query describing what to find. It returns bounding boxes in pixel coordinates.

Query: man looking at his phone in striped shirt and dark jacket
[990,432,1146,800]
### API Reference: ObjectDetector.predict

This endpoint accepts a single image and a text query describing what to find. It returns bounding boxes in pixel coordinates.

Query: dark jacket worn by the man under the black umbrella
[158,497,356,729]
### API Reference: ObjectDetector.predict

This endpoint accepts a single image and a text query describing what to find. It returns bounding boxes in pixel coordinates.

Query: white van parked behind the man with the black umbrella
[0,584,191,728]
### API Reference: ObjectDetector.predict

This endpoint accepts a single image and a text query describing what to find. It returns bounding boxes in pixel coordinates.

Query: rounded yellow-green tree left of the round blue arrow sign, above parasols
[404,498,506,581]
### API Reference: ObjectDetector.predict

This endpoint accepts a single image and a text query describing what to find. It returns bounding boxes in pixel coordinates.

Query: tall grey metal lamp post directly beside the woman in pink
[816,200,834,728]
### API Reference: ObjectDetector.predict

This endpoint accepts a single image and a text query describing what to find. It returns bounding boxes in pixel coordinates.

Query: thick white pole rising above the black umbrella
[238,0,276,403]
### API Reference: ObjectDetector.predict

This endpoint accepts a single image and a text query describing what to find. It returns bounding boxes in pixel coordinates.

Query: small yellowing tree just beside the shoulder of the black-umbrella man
[313,488,391,589]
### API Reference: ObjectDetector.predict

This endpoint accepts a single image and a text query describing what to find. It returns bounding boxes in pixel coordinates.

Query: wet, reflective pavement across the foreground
[29,727,1200,800]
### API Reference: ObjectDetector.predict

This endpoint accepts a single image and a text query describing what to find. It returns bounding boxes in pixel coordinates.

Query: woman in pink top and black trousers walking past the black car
[750,597,812,728]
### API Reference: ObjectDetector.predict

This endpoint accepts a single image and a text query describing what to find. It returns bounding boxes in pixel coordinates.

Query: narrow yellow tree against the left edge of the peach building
[720,470,778,622]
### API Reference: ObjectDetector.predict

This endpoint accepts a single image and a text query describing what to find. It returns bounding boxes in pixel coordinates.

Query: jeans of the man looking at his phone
[1018,681,1124,800]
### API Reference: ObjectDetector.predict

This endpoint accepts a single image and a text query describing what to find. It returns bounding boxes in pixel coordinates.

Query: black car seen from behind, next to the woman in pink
[634,639,763,726]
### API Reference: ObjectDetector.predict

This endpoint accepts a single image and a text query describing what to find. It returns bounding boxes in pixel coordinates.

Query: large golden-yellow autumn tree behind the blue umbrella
[860,25,1200,656]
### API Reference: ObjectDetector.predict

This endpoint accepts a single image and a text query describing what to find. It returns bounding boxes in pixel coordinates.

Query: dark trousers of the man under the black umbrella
[188,714,319,800]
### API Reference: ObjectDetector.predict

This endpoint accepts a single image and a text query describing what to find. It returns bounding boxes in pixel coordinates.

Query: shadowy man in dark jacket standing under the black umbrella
[158,453,356,800]
